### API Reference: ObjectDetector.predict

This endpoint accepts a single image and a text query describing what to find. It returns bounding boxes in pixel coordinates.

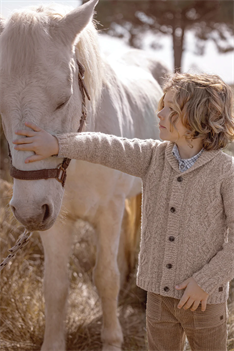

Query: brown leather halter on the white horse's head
[8,60,90,187]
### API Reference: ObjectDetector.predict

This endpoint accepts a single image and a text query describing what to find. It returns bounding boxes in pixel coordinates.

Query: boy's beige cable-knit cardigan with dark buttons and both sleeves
[56,133,234,304]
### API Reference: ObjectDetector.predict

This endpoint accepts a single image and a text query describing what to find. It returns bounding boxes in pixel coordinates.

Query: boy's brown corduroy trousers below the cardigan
[146,292,227,351]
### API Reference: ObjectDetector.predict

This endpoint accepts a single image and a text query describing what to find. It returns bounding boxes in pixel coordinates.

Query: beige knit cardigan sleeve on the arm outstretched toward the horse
[56,132,161,178]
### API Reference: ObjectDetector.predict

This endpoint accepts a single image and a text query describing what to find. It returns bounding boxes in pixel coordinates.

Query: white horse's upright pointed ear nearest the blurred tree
[59,0,99,43]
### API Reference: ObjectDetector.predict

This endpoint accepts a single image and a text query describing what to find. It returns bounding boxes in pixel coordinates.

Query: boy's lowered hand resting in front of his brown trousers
[175,277,209,312]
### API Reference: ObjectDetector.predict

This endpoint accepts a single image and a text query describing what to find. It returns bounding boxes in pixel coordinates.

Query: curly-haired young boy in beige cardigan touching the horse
[15,74,234,351]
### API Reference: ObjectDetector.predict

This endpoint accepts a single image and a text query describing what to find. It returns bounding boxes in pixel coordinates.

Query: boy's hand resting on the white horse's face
[13,123,59,163]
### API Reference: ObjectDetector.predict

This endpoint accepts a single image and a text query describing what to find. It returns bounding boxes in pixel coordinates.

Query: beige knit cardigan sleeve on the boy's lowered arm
[193,171,234,294]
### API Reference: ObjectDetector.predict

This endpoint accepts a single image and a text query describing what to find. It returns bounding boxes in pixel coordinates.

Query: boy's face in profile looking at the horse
[158,90,187,145]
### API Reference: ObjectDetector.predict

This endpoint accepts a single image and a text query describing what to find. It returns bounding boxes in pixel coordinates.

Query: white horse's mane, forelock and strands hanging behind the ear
[0,4,102,108]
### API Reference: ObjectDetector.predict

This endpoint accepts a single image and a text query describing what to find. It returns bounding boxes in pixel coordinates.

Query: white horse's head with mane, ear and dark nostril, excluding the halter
[0,0,100,230]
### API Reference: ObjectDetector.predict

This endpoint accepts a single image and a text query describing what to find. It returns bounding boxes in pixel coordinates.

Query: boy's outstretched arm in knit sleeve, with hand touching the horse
[14,123,161,178]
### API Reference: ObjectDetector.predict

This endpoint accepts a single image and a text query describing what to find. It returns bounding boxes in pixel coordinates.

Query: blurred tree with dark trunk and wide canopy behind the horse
[86,0,234,71]
